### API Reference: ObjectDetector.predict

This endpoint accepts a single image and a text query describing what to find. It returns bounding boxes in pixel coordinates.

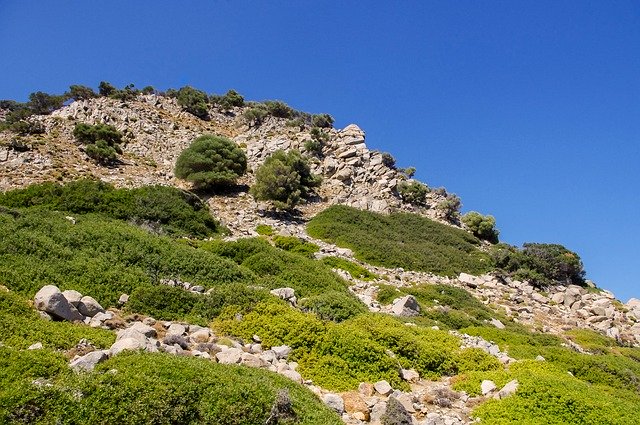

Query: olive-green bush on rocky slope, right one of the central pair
[251,150,320,210]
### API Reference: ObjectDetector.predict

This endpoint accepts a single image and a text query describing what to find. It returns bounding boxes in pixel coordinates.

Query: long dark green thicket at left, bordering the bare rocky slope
[0,180,220,237]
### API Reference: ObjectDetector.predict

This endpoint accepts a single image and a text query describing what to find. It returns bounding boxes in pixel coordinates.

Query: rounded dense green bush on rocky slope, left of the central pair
[175,135,247,189]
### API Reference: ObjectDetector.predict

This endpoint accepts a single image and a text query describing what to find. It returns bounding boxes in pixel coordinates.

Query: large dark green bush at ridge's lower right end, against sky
[491,243,585,287]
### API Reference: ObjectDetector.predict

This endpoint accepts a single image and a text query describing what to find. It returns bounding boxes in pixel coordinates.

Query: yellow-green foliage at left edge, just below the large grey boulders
[0,290,115,350]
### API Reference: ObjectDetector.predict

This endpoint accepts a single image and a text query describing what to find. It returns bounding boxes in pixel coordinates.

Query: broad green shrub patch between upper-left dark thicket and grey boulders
[0,210,252,307]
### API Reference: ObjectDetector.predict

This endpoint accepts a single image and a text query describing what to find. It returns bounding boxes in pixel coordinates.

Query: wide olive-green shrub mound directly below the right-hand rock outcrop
[307,205,491,276]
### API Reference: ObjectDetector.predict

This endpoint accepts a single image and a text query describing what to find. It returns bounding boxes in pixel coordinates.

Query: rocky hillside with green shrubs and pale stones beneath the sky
[0,84,640,425]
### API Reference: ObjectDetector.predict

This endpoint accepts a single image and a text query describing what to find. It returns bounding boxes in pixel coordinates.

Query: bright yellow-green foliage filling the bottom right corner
[454,360,640,425]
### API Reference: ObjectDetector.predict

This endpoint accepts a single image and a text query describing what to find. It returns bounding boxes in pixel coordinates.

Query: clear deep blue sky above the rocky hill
[0,0,640,300]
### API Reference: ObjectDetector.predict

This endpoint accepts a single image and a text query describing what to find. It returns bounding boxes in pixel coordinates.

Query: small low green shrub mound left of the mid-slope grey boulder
[300,291,367,322]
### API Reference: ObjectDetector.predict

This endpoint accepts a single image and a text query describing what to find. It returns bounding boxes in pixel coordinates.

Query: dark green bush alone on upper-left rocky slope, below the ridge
[73,123,122,164]
